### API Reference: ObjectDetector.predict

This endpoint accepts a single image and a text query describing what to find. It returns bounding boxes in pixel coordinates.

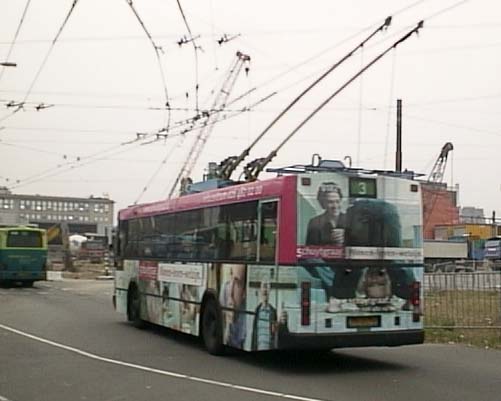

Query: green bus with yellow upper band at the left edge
[0,226,47,287]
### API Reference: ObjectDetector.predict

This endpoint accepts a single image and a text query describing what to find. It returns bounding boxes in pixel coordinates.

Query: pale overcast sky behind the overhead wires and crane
[0,0,501,217]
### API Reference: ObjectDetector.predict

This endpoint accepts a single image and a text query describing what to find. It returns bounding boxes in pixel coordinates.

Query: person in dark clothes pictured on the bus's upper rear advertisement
[306,182,346,246]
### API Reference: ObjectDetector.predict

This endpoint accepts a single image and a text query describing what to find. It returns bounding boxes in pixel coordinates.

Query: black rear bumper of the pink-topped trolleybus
[279,330,424,349]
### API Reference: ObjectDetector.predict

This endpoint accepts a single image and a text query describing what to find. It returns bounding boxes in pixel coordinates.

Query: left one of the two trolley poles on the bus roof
[220,16,392,179]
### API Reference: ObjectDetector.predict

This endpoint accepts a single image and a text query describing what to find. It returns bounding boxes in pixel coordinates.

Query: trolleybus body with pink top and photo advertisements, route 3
[114,162,424,354]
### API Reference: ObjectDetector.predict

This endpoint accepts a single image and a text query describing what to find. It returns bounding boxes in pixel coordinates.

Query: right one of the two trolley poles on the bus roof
[245,21,424,181]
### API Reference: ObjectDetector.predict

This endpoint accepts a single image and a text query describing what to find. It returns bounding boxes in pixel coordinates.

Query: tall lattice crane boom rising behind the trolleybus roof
[169,52,250,198]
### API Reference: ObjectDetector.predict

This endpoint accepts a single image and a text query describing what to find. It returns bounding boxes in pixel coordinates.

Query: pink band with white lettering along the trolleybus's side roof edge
[118,176,296,220]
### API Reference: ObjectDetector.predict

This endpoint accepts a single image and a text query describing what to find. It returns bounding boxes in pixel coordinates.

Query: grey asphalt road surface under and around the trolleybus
[0,280,501,401]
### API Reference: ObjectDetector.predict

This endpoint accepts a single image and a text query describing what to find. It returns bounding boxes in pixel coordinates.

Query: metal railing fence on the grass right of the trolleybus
[423,271,501,329]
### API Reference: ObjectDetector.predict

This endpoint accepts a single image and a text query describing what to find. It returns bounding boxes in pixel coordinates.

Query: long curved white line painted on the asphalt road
[0,324,325,401]
